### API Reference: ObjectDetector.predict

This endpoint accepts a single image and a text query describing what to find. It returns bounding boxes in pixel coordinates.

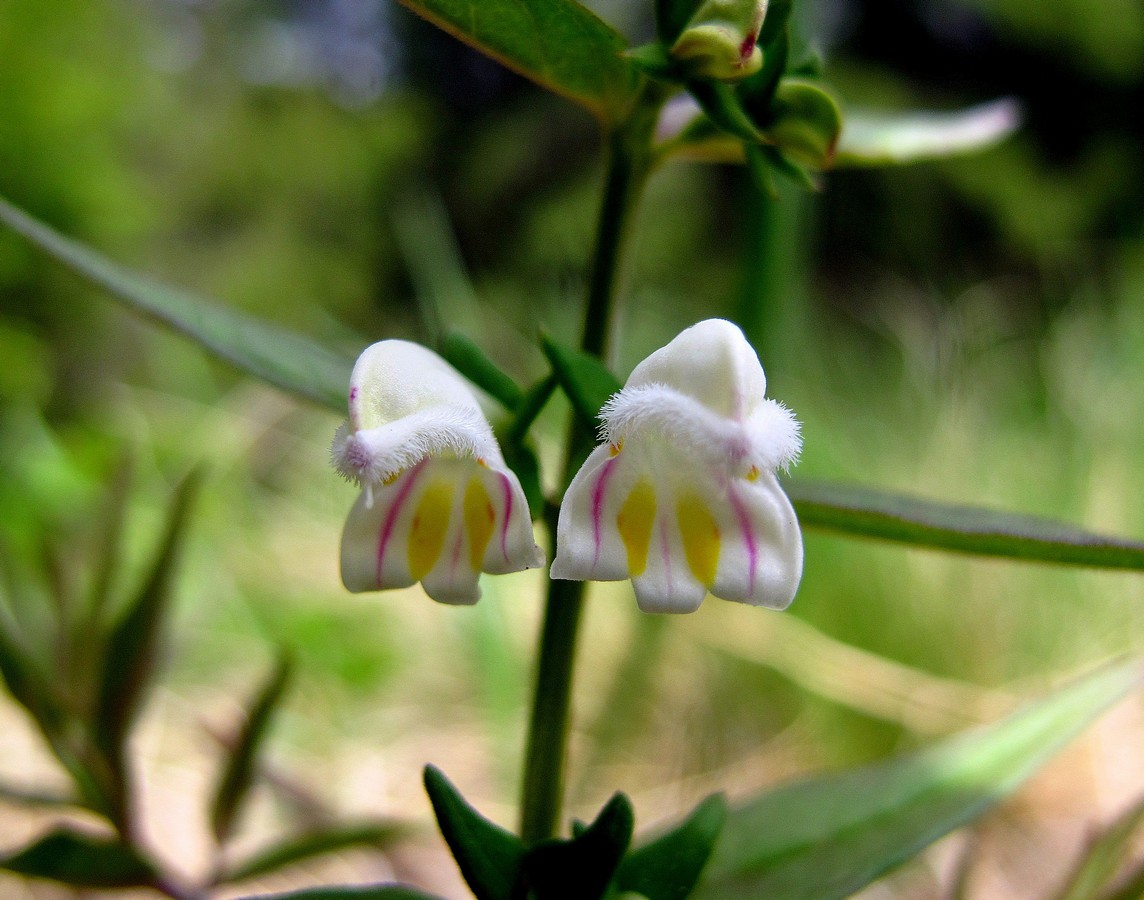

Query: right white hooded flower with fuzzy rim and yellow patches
[551,319,802,613]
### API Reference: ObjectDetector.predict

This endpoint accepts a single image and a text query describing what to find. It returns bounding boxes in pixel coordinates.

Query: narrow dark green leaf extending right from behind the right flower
[787,481,1144,570]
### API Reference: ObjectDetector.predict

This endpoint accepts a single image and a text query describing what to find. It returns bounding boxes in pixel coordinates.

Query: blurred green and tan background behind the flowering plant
[0,0,1144,895]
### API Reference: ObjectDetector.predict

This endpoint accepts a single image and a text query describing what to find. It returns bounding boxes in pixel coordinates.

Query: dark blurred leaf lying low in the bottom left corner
[0,829,157,887]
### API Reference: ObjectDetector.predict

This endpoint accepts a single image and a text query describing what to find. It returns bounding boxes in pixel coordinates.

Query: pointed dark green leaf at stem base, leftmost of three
[424,765,524,900]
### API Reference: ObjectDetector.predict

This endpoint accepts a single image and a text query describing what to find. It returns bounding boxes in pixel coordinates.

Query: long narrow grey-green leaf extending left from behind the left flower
[0,199,353,413]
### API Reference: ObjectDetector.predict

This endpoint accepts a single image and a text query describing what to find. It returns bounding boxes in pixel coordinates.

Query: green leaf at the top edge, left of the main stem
[402,0,639,122]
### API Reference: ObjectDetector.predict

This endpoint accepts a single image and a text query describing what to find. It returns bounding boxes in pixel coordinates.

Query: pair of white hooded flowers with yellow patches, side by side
[332,319,802,613]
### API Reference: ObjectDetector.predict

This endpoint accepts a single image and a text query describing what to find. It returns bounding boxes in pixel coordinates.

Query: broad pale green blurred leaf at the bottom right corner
[696,660,1144,900]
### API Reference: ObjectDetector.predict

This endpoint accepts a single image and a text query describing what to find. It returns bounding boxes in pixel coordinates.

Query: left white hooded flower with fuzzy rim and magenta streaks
[331,341,545,604]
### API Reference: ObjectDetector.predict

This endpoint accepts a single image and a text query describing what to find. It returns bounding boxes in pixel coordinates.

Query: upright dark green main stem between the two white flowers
[521,85,665,844]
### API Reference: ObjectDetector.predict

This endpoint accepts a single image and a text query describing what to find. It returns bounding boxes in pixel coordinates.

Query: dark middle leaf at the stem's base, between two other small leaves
[524,794,640,900]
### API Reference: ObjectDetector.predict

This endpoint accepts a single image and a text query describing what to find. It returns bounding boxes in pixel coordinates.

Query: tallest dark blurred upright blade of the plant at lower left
[93,472,200,800]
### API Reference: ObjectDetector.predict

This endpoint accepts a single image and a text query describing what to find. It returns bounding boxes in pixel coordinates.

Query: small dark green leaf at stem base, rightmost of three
[617,794,726,900]
